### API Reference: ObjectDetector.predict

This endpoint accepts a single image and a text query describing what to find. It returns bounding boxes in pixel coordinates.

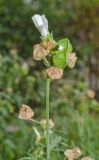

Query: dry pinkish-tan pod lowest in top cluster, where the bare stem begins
[46,67,63,80]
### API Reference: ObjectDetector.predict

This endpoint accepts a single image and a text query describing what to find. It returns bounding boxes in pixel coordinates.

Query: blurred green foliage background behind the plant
[0,0,99,160]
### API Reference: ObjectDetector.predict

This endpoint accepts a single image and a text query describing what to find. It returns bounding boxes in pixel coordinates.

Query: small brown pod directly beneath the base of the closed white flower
[42,39,56,50]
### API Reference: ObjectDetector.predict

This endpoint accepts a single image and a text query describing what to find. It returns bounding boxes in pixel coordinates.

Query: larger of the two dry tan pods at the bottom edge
[64,147,81,160]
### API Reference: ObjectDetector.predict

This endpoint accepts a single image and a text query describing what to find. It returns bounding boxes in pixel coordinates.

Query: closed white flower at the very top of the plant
[32,14,49,37]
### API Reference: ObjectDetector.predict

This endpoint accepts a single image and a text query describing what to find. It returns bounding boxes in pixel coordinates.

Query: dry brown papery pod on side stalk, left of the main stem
[19,104,34,120]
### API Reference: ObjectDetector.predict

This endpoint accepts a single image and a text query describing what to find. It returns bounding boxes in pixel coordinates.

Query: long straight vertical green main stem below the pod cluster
[46,78,50,160]
